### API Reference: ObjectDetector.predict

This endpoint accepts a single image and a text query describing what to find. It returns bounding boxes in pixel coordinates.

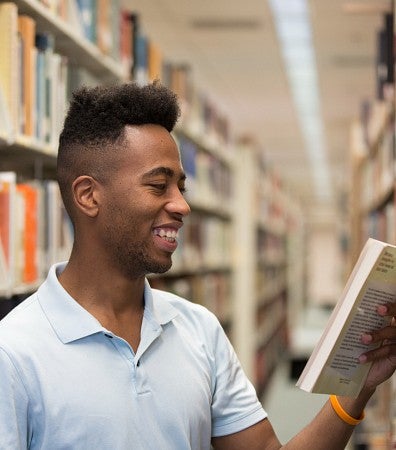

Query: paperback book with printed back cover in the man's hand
[297,238,396,397]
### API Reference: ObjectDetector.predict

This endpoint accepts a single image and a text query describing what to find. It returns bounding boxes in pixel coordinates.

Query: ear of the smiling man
[72,175,99,217]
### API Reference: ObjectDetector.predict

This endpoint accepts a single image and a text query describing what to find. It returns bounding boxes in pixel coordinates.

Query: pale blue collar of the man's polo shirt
[37,262,178,344]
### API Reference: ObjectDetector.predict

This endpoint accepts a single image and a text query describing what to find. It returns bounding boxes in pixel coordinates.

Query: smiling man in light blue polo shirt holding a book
[0,83,396,450]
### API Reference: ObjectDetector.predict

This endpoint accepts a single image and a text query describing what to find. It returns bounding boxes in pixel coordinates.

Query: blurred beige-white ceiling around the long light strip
[120,0,391,224]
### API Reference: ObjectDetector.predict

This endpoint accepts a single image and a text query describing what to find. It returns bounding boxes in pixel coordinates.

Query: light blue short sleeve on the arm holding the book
[212,318,267,437]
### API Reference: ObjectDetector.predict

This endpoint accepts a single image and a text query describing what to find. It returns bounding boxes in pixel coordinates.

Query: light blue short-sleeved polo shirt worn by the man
[0,263,266,450]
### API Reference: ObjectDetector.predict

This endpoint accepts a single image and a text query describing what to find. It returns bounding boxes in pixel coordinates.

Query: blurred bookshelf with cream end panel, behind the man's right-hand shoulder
[232,139,303,394]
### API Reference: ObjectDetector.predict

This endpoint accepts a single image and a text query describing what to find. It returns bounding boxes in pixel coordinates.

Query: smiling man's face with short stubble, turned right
[98,125,190,278]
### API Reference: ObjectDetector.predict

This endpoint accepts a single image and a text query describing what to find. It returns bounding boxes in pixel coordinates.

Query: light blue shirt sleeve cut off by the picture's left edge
[0,348,28,450]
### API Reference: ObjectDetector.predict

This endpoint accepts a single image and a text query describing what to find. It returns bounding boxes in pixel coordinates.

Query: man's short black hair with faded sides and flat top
[57,81,180,221]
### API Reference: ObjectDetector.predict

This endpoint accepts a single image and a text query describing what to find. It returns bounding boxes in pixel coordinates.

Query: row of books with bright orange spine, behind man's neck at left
[0,172,73,296]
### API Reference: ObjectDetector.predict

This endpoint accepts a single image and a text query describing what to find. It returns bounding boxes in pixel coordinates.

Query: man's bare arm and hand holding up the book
[213,304,396,450]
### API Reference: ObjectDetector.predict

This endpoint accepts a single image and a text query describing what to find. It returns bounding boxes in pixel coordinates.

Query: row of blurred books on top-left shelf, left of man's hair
[0,2,86,152]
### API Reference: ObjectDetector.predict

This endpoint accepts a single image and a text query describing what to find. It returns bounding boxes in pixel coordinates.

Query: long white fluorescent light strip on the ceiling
[269,0,332,200]
